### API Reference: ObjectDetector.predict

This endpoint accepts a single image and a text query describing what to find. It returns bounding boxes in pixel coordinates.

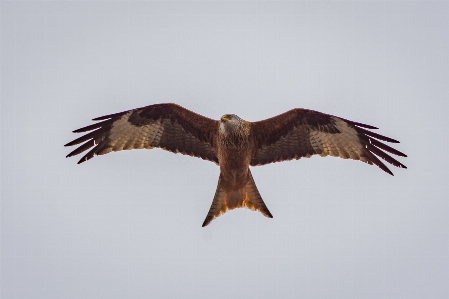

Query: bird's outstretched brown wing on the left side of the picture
[65,104,219,164]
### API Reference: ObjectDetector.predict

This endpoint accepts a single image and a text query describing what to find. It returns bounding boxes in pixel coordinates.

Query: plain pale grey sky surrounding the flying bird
[0,1,449,299]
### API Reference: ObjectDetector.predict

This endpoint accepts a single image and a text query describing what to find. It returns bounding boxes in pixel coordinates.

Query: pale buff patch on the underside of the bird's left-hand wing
[109,111,164,151]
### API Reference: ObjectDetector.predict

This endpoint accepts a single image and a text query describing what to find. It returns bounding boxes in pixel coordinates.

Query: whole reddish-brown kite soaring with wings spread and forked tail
[65,103,407,227]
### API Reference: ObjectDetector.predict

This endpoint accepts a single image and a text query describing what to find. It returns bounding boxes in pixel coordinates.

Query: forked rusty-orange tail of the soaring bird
[203,170,273,227]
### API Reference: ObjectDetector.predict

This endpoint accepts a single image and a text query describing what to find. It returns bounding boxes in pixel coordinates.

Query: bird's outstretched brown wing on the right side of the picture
[251,109,407,175]
